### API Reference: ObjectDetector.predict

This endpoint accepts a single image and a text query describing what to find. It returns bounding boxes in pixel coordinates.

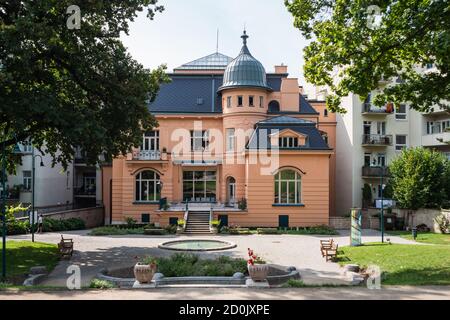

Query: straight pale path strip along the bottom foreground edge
[0,286,450,300]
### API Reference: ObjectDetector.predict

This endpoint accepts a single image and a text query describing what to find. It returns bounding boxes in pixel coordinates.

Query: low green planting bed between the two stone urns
[145,253,247,277]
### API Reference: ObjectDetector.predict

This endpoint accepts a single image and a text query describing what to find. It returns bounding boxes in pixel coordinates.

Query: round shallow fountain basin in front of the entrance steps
[158,239,236,251]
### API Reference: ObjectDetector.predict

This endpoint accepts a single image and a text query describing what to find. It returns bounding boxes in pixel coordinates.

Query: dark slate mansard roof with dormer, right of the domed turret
[247,116,331,150]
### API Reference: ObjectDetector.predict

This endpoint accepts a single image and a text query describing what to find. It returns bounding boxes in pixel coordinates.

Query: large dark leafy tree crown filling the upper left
[0,0,168,167]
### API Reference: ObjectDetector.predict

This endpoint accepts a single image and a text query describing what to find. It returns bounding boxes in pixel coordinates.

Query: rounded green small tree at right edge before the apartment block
[389,148,450,210]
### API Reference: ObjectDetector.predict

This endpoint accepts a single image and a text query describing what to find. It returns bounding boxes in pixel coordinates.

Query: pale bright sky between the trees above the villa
[122,0,307,85]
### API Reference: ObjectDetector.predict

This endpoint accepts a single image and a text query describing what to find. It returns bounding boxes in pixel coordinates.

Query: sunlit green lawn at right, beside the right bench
[338,243,450,285]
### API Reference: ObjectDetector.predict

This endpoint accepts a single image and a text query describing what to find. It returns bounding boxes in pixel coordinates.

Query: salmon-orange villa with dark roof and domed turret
[102,32,336,231]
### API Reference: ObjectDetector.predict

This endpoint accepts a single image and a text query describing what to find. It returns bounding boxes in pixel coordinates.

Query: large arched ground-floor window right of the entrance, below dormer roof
[275,169,302,204]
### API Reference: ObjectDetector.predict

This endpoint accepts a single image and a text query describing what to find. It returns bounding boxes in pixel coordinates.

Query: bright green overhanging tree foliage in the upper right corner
[285,0,450,112]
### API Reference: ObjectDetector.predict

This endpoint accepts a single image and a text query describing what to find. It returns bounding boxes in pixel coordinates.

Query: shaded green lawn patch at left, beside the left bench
[0,240,59,284]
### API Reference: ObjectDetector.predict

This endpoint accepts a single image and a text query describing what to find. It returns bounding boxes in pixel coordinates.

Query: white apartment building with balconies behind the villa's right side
[315,66,450,216]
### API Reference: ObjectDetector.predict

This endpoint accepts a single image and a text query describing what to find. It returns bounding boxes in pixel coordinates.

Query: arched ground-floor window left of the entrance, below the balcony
[136,170,161,202]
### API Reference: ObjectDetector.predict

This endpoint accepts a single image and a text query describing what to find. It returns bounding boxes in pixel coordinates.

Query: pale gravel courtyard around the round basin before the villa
[10,230,415,286]
